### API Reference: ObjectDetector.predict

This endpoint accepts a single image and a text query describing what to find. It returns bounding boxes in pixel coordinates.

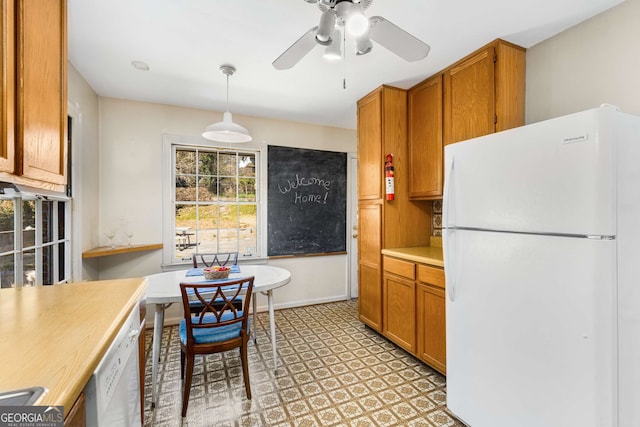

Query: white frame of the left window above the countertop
[0,189,73,287]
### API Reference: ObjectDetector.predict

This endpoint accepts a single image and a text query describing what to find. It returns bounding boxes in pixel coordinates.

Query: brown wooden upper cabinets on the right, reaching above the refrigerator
[408,40,526,200]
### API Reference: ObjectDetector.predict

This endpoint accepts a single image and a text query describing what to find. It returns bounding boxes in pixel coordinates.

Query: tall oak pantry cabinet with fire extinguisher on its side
[358,86,431,332]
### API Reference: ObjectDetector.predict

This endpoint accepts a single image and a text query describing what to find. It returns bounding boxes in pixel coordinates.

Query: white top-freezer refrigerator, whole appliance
[442,106,640,427]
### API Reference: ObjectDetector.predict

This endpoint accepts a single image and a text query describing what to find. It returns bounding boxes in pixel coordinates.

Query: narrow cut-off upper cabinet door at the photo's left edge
[0,0,15,173]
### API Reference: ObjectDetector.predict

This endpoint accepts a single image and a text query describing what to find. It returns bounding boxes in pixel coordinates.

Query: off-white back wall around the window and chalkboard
[92,97,356,324]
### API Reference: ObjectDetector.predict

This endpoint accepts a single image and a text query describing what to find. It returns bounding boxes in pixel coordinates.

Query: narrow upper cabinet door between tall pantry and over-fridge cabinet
[408,74,442,199]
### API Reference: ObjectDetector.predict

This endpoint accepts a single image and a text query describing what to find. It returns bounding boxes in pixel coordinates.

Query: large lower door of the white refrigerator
[445,230,617,427]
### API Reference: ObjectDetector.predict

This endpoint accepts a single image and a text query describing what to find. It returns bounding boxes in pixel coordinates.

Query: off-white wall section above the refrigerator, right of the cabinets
[526,0,640,123]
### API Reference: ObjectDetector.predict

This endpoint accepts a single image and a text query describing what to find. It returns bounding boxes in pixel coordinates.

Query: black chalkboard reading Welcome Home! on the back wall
[267,145,347,256]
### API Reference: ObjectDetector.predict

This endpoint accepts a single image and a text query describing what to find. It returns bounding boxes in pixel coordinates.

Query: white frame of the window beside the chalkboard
[162,134,267,270]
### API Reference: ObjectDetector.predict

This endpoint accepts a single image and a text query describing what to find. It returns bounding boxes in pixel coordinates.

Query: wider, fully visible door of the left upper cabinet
[16,0,67,184]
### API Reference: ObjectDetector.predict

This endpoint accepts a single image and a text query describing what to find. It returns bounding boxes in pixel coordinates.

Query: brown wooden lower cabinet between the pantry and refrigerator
[382,256,446,374]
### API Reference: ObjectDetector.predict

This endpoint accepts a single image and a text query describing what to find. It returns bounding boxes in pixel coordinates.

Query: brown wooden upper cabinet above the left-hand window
[0,0,67,191]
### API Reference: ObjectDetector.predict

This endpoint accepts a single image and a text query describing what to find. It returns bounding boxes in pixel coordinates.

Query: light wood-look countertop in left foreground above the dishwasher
[0,278,147,416]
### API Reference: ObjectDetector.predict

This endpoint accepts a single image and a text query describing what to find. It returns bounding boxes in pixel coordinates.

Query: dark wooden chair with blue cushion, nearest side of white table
[179,276,254,417]
